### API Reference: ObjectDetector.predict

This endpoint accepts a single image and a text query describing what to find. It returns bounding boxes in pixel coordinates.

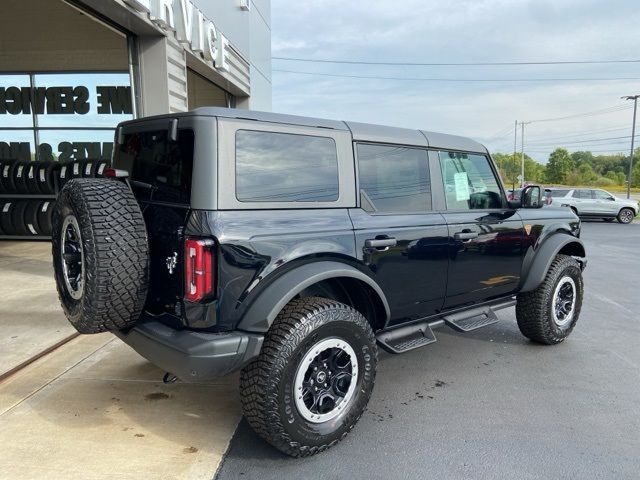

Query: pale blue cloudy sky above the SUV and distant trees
[272,0,640,162]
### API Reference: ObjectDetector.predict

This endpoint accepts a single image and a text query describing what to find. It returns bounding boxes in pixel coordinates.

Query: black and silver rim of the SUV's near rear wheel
[294,338,358,423]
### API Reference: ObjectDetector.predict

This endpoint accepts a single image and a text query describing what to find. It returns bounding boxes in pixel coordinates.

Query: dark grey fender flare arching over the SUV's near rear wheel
[238,261,390,332]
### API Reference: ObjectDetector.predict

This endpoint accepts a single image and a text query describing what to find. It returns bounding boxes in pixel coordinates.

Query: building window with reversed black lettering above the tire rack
[0,73,133,161]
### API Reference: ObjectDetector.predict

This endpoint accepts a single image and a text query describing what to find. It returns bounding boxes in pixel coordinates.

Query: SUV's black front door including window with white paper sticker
[437,151,524,308]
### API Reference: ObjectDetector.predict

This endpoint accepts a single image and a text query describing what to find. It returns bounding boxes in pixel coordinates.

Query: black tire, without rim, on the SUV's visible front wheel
[516,255,584,345]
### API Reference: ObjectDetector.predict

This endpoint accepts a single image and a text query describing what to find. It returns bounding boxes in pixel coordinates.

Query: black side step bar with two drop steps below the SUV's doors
[376,301,515,353]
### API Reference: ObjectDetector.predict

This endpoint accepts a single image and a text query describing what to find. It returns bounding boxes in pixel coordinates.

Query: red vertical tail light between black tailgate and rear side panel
[184,238,214,302]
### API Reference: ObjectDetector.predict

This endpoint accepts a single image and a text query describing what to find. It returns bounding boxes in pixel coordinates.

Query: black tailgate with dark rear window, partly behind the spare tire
[114,119,195,315]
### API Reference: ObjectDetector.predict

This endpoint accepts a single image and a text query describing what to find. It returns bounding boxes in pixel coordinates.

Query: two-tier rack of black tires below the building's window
[0,159,109,240]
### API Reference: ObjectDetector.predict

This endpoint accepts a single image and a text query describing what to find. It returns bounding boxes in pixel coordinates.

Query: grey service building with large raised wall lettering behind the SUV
[0,0,271,161]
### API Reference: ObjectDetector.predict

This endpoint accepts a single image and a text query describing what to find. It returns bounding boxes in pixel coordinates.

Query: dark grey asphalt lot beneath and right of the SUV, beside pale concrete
[217,221,640,480]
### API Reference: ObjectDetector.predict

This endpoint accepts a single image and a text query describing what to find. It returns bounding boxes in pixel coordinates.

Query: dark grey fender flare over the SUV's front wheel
[520,233,586,292]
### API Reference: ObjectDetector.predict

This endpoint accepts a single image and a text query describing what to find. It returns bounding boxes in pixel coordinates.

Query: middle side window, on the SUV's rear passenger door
[357,144,431,213]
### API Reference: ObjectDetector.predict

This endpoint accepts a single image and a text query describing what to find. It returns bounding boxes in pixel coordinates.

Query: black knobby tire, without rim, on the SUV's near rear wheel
[240,297,377,457]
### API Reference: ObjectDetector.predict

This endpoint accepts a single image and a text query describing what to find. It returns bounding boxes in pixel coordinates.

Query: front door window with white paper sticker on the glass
[438,152,504,210]
